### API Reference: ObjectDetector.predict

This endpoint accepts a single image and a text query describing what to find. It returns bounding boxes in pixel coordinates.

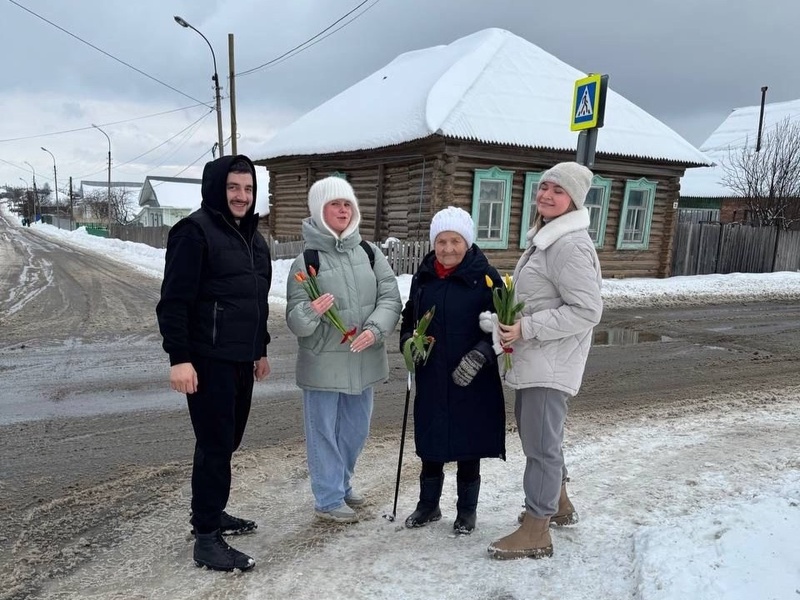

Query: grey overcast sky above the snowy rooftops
[0,0,800,195]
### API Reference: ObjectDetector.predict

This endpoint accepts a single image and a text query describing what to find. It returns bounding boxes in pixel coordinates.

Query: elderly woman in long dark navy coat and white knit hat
[400,206,505,534]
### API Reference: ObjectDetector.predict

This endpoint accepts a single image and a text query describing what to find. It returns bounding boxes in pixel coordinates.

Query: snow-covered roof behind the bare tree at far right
[681,100,800,198]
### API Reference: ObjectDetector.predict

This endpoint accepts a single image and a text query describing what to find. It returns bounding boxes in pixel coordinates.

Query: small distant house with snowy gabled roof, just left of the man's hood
[135,175,202,227]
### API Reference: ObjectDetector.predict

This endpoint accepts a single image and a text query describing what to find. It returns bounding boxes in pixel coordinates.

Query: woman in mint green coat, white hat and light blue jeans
[286,177,401,523]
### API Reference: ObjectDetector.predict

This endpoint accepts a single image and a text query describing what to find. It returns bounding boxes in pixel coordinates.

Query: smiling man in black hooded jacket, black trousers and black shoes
[156,155,272,571]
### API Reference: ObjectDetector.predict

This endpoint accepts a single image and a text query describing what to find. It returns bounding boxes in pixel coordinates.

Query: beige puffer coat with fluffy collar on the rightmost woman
[501,208,603,396]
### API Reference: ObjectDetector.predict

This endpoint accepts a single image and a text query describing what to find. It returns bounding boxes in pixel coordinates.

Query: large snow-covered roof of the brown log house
[252,29,711,165]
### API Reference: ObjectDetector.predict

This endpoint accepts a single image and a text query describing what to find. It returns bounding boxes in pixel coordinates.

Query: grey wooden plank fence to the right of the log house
[672,223,800,275]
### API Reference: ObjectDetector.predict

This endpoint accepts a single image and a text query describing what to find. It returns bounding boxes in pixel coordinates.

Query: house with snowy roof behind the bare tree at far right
[679,100,800,223]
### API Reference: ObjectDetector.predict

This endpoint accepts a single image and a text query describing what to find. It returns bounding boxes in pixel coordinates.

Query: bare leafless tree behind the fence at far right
[722,118,800,229]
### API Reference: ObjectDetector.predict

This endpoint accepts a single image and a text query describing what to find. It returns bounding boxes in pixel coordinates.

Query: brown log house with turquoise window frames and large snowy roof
[251,29,711,277]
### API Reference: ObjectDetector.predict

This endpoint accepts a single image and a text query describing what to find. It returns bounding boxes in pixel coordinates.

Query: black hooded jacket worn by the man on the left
[156,155,272,365]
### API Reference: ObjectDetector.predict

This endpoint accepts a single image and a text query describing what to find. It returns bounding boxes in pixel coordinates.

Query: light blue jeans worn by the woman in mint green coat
[303,387,372,512]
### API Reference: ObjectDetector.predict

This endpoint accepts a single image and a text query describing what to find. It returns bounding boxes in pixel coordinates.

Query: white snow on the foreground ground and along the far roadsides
[6,213,800,600]
